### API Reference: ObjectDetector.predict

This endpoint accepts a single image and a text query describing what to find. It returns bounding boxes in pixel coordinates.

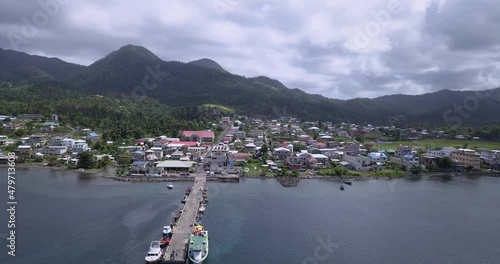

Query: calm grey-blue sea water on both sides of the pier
[0,168,500,264]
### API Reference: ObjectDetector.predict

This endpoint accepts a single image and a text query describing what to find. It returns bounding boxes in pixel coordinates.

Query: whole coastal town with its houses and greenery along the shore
[0,114,500,178]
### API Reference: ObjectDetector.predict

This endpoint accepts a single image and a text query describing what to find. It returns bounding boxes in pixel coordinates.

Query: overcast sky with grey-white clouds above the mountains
[0,0,500,99]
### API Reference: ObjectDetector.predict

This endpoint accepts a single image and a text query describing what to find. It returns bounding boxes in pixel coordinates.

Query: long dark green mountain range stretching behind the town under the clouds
[0,45,500,124]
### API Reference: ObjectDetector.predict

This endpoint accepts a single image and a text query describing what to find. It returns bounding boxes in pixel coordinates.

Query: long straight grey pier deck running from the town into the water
[161,175,206,264]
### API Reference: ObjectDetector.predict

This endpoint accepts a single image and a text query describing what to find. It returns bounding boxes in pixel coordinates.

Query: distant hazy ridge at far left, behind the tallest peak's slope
[0,48,85,81]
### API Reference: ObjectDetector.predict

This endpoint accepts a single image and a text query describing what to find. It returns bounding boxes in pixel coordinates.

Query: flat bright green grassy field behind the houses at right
[374,139,500,150]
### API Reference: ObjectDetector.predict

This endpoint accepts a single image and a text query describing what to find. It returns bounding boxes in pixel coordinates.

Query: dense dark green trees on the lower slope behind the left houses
[0,84,218,140]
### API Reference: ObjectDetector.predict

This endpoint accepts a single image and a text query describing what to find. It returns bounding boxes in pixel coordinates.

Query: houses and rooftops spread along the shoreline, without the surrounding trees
[0,114,500,173]
